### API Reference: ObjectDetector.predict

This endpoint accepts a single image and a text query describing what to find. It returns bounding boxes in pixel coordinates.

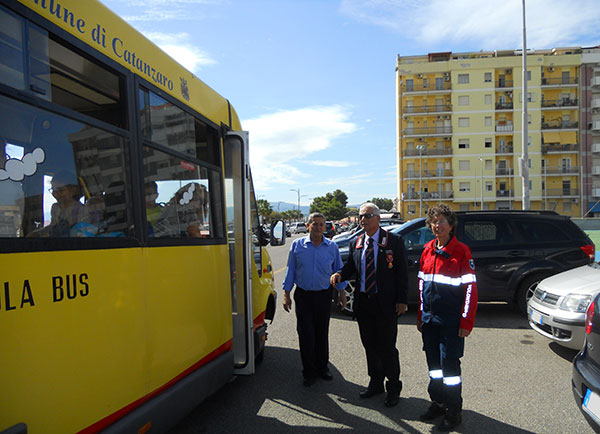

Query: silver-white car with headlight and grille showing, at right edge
[527,262,600,350]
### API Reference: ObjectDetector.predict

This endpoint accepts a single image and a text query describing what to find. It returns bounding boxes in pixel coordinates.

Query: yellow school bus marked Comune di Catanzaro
[0,0,282,434]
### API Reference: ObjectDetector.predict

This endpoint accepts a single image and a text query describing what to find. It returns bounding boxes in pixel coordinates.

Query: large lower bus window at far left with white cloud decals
[0,96,133,238]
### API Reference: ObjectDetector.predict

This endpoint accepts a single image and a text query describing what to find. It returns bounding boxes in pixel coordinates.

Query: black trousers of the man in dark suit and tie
[356,292,402,393]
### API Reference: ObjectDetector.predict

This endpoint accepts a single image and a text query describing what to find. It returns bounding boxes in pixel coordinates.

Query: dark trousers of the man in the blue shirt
[294,287,331,378]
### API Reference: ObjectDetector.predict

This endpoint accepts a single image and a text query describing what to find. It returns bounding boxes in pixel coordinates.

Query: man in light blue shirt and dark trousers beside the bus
[283,213,346,387]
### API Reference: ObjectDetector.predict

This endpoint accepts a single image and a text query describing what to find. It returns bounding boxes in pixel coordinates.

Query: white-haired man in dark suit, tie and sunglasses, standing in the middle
[331,202,408,407]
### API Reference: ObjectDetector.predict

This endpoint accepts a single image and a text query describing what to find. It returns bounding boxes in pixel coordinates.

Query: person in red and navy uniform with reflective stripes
[417,204,477,431]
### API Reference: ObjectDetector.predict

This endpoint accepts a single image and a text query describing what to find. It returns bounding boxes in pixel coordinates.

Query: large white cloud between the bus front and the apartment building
[242,105,357,190]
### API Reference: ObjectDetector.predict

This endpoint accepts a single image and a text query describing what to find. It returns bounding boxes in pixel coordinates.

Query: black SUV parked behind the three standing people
[340,211,595,313]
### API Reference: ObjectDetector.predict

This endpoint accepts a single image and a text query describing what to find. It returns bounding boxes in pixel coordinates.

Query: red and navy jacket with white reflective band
[417,236,477,331]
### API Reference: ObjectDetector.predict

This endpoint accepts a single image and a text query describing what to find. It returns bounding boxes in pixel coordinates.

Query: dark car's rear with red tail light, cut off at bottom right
[571,295,600,432]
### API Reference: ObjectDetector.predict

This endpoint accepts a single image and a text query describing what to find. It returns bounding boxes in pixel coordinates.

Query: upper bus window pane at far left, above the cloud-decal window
[0,5,126,128]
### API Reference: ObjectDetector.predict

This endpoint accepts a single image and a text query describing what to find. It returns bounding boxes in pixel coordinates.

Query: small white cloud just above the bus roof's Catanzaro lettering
[143,32,217,73]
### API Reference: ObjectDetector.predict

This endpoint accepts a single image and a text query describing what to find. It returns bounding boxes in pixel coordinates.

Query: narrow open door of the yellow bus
[223,131,254,374]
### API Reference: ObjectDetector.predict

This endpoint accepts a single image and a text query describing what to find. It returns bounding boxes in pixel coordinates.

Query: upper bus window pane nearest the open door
[139,89,220,166]
